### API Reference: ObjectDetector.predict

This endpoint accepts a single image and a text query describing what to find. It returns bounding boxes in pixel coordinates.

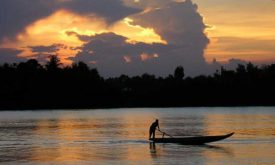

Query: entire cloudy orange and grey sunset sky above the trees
[0,0,275,77]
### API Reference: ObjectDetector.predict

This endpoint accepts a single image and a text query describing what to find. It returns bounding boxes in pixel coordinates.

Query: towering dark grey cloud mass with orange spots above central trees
[71,0,211,76]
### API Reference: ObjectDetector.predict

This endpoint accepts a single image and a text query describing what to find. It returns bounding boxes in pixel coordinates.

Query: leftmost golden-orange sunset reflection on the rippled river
[31,119,87,163]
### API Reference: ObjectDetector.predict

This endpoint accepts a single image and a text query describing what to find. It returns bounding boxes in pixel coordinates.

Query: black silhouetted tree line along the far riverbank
[0,56,275,110]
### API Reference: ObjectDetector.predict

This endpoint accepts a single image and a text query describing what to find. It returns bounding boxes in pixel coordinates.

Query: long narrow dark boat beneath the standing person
[150,132,234,145]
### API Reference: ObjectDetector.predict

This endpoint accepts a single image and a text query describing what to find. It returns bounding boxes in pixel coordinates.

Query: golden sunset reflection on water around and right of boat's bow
[203,114,275,165]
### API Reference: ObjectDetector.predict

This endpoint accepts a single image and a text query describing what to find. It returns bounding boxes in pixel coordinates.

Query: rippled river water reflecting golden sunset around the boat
[0,107,275,165]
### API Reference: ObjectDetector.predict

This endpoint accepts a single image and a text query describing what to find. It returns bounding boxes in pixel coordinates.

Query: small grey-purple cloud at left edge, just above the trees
[0,48,24,64]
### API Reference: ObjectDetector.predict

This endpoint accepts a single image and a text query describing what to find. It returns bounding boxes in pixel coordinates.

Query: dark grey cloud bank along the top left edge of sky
[0,0,140,41]
